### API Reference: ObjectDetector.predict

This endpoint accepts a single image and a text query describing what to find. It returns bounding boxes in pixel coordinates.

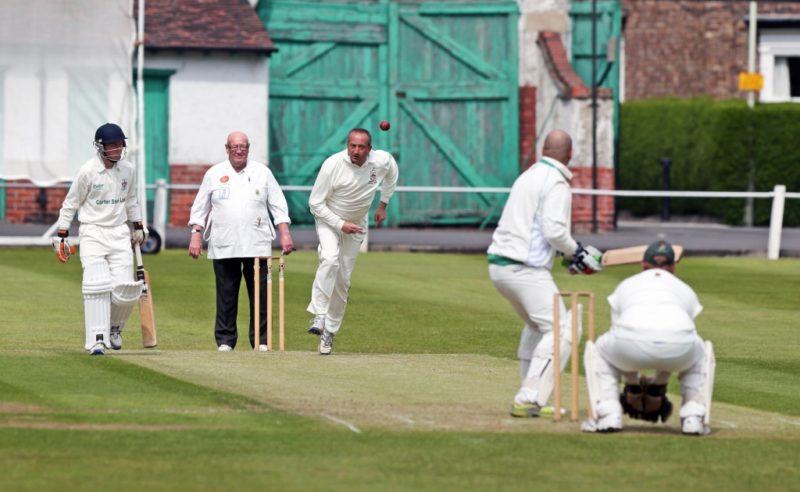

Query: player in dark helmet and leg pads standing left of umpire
[53,123,147,355]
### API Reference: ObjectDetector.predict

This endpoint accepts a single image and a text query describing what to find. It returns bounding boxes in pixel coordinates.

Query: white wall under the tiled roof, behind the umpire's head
[145,52,269,165]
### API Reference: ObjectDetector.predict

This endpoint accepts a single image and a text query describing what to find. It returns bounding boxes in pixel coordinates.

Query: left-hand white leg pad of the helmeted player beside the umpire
[82,262,111,350]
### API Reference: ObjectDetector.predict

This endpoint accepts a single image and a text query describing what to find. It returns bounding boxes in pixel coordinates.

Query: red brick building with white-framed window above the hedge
[621,0,800,101]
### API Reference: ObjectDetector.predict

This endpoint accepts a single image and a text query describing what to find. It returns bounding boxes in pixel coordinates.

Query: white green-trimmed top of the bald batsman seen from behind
[487,157,578,268]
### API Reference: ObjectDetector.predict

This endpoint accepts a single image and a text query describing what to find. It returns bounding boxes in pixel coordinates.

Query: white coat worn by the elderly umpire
[189,160,290,259]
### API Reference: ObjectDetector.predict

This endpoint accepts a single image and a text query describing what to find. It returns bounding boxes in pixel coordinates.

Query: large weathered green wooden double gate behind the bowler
[259,0,519,225]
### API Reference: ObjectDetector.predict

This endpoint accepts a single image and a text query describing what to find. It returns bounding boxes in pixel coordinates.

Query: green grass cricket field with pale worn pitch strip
[0,248,800,491]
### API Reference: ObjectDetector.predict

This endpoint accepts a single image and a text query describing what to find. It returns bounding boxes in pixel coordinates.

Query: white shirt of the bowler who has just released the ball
[308,150,398,230]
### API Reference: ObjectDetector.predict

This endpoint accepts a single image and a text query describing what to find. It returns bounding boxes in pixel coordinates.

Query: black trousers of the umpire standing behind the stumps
[213,258,267,348]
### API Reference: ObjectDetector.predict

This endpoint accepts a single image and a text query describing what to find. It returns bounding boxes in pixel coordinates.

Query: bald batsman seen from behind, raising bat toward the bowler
[488,130,602,417]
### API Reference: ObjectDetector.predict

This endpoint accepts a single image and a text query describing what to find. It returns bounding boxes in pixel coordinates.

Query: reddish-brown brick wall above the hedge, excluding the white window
[622,0,800,100]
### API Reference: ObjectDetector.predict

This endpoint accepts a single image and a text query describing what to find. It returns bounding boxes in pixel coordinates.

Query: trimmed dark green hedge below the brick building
[617,98,800,226]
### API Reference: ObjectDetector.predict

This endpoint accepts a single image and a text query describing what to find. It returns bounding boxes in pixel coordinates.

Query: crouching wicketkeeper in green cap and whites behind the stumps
[581,241,715,435]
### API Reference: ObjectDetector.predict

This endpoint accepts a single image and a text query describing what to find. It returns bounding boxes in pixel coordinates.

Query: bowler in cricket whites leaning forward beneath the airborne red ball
[307,128,398,355]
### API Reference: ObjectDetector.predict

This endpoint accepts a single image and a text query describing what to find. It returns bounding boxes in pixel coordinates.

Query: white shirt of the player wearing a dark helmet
[58,156,142,229]
